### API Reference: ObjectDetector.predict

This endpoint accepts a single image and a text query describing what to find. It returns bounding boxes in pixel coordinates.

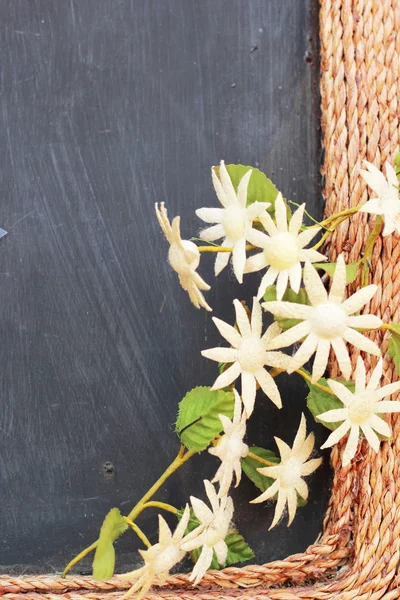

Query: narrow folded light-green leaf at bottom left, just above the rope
[93,508,128,581]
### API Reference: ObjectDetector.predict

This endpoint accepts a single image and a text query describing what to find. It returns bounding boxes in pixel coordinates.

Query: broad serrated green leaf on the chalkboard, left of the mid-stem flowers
[176,386,235,452]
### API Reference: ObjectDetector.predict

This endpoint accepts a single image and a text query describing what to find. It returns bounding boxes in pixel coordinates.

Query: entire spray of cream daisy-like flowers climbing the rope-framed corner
[114,156,400,597]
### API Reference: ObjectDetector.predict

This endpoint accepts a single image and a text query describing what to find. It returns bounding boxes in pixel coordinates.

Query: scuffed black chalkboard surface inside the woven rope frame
[0,0,329,572]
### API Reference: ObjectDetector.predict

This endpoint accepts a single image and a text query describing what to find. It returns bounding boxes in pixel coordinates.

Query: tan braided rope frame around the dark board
[0,0,400,600]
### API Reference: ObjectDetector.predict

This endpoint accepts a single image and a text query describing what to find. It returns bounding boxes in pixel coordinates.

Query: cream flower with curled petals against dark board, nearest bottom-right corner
[251,415,322,529]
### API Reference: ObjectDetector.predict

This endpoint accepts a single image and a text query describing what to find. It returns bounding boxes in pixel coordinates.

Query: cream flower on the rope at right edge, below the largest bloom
[318,356,400,467]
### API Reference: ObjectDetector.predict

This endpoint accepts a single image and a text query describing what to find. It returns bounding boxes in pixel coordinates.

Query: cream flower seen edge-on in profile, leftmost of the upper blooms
[155,202,212,310]
